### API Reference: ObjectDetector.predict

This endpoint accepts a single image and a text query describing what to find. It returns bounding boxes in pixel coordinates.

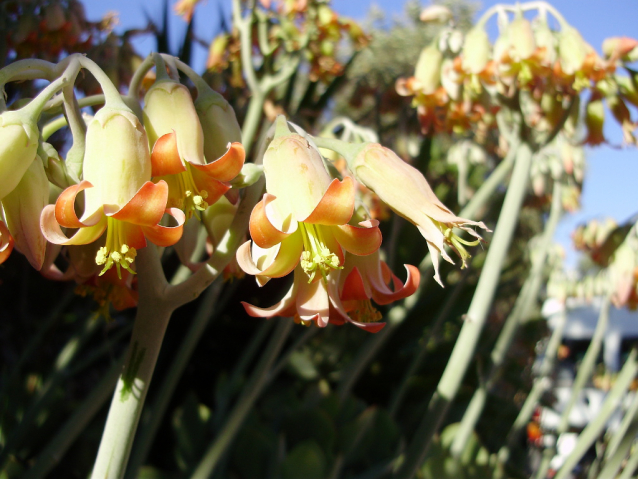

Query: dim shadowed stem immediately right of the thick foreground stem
[126,281,224,478]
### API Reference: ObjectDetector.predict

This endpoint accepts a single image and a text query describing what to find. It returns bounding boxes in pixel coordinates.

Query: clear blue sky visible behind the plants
[85,0,638,266]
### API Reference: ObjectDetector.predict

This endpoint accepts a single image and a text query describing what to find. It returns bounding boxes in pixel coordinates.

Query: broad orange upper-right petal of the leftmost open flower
[110,181,168,226]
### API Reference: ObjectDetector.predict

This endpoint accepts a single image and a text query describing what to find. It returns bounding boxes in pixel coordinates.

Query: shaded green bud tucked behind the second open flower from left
[195,90,241,161]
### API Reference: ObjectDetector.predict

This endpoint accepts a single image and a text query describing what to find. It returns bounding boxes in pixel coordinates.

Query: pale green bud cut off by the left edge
[0,111,40,200]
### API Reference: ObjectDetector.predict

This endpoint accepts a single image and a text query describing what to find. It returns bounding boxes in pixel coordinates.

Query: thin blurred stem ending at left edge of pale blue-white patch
[494,311,567,478]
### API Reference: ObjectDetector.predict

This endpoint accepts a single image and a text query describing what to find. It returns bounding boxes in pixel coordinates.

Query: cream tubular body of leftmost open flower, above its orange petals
[83,107,151,219]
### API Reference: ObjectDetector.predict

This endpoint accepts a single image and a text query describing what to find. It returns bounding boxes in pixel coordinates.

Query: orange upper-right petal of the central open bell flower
[303,177,354,225]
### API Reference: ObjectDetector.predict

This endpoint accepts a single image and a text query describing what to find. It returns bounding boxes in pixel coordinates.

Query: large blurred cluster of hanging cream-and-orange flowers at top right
[396,3,638,145]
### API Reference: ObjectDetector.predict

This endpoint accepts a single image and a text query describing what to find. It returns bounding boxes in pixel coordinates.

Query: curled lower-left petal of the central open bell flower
[237,233,303,278]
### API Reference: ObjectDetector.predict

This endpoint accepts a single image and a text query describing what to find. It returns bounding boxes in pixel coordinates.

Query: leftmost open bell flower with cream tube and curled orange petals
[40,105,184,274]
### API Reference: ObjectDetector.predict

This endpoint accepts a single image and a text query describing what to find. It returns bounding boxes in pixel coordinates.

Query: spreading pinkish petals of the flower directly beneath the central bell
[242,265,385,333]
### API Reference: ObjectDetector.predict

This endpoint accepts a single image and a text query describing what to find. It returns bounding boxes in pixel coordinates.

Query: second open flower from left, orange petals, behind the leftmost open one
[144,80,245,218]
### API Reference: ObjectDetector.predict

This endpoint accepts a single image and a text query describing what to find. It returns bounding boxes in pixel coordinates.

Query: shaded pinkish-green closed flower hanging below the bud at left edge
[2,159,49,271]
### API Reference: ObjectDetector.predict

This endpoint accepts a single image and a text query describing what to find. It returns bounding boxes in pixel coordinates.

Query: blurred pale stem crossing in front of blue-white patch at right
[556,295,611,436]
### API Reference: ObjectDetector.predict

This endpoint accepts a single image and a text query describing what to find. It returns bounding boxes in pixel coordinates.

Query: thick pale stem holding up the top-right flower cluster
[395,143,532,479]
